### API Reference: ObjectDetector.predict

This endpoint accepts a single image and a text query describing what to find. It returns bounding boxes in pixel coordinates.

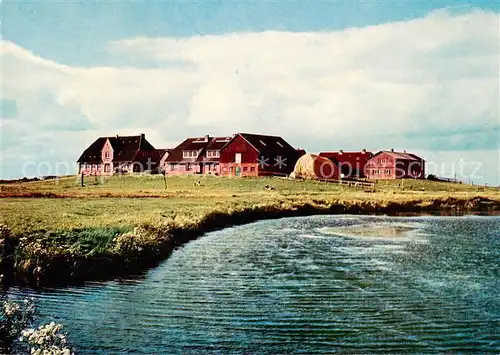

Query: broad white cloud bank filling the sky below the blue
[2,10,500,184]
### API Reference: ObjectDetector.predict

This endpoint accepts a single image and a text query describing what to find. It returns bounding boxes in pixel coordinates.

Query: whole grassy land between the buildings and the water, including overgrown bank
[0,176,500,284]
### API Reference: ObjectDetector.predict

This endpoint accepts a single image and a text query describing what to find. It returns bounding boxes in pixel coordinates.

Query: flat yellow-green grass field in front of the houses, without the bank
[0,175,500,233]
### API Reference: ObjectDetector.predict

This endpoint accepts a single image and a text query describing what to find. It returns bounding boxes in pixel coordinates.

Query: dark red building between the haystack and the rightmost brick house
[319,149,373,178]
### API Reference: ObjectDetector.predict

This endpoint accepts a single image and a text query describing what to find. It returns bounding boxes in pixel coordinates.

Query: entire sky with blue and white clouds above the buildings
[0,0,500,185]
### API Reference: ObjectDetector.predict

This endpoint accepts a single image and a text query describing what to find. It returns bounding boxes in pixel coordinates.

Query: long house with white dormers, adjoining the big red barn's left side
[162,135,231,175]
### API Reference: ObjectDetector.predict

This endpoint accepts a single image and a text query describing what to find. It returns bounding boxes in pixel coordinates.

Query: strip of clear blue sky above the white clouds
[3,0,499,65]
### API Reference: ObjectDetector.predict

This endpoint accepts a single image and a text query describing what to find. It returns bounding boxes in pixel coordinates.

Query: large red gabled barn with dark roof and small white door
[220,133,303,176]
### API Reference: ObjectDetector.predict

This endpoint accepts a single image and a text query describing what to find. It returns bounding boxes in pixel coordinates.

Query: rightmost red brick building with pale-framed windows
[365,150,425,179]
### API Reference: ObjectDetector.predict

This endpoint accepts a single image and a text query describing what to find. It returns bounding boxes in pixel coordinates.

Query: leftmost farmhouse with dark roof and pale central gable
[77,134,160,175]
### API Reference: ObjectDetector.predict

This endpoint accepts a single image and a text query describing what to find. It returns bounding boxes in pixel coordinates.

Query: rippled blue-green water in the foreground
[7,216,500,354]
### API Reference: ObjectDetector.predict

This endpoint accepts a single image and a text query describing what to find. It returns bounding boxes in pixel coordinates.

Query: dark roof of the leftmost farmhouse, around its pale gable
[78,134,156,164]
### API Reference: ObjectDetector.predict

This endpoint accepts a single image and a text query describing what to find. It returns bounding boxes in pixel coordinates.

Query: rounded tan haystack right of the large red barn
[290,154,339,180]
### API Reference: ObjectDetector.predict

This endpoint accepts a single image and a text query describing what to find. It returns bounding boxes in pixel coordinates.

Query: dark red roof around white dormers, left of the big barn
[166,137,231,163]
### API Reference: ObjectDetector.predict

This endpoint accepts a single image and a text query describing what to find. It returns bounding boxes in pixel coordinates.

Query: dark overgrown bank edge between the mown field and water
[2,197,500,285]
